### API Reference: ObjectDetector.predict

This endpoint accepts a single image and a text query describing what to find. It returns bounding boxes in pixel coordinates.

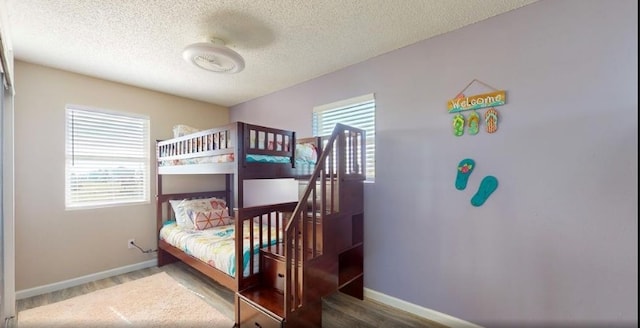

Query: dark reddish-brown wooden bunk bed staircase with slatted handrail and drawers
[236,124,365,328]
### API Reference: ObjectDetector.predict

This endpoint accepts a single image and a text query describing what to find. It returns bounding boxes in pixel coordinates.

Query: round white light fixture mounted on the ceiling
[182,38,244,74]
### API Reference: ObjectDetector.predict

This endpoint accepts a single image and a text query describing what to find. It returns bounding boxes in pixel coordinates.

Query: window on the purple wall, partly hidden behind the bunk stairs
[313,94,376,180]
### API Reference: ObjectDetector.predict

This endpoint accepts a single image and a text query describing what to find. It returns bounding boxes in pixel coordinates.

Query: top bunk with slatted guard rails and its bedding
[156,122,321,179]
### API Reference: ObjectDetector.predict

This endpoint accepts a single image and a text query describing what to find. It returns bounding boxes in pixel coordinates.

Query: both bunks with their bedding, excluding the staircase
[156,122,320,291]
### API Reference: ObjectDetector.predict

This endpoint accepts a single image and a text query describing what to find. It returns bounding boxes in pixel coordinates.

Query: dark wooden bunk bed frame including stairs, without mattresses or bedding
[157,122,366,327]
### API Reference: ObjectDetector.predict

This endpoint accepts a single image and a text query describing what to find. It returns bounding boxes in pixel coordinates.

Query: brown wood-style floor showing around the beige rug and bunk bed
[13,262,446,328]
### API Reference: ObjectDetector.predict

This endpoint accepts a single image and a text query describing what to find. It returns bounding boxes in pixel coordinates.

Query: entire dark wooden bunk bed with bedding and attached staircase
[156,122,365,327]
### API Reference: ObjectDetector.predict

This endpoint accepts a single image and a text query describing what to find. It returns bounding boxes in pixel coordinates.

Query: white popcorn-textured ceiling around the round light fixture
[5,0,535,106]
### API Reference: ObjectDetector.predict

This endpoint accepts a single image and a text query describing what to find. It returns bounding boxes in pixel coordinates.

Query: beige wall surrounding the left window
[15,61,229,291]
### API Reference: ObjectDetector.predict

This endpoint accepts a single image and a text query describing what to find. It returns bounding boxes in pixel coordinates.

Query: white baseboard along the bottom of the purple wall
[364,288,482,328]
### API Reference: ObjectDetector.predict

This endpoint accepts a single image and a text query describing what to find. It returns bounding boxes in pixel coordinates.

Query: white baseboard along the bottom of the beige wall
[16,259,158,300]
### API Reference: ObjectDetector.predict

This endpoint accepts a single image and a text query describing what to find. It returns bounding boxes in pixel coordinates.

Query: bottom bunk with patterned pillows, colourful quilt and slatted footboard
[157,191,296,291]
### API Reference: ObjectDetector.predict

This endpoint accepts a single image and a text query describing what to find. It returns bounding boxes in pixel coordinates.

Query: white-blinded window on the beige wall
[65,106,150,208]
